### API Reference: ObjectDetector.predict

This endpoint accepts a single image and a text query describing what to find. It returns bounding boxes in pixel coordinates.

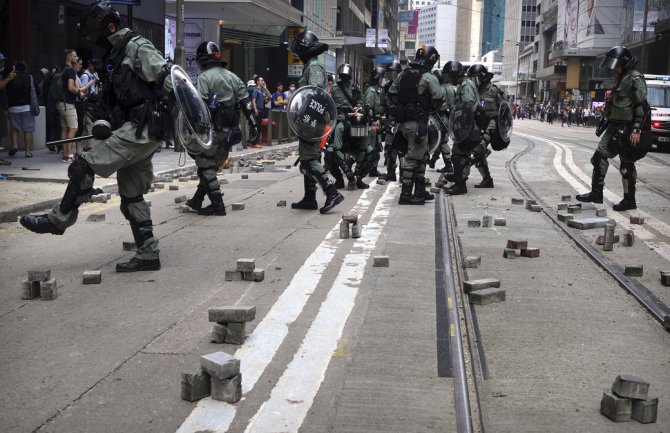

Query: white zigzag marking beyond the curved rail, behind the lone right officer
[518,133,670,261]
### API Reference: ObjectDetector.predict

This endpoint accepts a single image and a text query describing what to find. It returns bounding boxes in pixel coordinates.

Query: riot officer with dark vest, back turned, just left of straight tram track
[389,45,443,205]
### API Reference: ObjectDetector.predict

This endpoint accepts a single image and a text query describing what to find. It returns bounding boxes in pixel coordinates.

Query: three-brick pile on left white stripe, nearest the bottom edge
[181,352,242,403]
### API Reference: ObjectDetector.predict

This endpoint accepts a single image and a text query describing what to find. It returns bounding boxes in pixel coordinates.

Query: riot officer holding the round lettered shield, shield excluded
[287,31,344,213]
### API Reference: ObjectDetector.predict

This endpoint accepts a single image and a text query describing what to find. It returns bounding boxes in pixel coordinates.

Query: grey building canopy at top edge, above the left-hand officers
[165,0,302,28]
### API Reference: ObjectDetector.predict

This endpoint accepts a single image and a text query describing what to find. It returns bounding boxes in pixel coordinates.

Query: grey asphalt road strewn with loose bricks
[0,121,670,432]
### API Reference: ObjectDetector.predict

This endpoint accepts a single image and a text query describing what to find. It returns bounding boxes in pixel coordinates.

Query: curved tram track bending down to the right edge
[505,137,670,330]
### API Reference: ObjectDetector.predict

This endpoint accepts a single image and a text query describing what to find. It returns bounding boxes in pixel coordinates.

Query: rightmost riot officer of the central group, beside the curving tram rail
[468,64,506,188]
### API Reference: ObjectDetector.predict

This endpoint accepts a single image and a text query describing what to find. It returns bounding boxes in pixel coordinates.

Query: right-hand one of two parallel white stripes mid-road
[245,183,398,433]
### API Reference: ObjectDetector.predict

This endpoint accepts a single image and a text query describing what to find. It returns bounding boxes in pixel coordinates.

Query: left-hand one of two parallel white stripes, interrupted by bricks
[177,183,377,433]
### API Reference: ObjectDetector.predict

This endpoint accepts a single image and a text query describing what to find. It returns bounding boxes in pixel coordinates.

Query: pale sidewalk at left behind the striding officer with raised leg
[0,142,298,223]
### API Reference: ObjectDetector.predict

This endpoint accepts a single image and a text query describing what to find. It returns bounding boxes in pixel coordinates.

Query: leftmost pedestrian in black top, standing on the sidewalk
[3,60,39,158]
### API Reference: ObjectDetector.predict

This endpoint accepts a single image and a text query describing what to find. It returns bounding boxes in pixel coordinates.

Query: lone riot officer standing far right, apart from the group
[576,46,650,211]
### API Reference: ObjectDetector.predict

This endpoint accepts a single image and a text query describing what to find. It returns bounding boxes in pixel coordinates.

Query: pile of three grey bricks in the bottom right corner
[600,375,658,424]
